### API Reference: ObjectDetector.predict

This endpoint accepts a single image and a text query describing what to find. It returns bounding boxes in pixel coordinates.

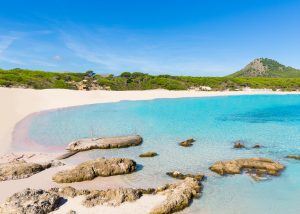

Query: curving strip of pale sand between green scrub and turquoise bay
[0,87,300,155]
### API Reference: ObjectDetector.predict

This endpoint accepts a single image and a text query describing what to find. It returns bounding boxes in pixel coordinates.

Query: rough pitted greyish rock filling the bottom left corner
[0,189,61,214]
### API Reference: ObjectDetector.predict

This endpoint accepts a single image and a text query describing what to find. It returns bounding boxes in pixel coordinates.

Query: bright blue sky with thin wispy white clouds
[0,0,300,76]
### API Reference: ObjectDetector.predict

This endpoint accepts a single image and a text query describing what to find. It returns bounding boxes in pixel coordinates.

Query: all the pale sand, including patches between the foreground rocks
[0,88,299,213]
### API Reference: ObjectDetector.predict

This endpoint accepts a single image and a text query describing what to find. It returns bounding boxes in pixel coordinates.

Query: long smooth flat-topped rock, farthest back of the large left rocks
[67,135,143,151]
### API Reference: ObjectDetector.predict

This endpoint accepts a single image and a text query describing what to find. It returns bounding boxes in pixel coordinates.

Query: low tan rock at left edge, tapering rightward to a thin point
[0,161,62,181]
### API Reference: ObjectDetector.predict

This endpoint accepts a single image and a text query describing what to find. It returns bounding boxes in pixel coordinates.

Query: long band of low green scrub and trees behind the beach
[0,69,300,91]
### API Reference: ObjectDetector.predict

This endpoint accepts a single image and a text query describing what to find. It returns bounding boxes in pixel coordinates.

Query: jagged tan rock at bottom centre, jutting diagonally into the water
[150,177,201,214]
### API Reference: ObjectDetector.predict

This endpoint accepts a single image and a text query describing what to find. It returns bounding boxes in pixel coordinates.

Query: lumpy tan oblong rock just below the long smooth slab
[52,158,136,183]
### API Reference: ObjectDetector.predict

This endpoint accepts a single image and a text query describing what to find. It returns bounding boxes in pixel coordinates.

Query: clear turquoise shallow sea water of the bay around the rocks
[17,95,300,214]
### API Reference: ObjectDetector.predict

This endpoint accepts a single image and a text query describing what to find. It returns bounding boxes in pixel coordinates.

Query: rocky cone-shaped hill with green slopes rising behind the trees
[229,58,300,78]
